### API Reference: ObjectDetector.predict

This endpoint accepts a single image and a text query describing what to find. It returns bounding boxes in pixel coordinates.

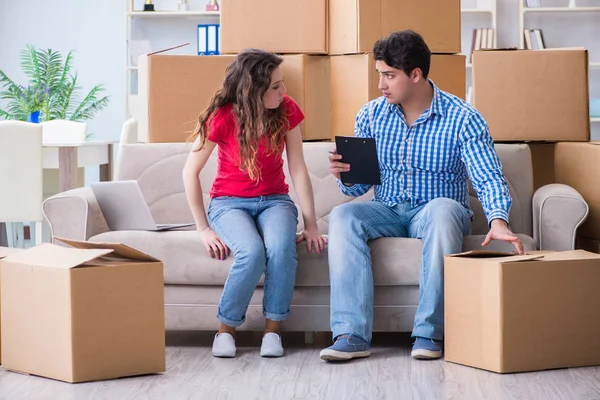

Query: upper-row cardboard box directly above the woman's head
[221,0,327,54]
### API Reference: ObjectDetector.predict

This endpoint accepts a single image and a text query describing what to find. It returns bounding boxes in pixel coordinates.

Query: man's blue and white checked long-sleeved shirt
[338,81,512,224]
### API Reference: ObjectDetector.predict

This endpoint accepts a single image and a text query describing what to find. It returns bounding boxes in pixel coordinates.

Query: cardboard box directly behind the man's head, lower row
[331,54,466,136]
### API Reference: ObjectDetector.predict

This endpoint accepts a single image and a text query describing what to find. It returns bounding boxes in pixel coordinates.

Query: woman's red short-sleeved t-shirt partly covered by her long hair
[208,95,304,197]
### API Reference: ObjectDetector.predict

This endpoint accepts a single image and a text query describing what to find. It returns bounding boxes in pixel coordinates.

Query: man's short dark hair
[373,30,431,78]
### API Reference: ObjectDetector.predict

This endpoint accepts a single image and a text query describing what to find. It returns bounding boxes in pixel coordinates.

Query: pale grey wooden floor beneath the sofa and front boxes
[0,332,600,400]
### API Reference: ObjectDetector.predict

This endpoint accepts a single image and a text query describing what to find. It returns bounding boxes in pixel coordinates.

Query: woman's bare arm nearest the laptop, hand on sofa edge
[182,140,229,260]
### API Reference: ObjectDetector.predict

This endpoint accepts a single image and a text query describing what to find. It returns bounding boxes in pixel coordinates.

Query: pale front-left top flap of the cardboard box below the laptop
[4,243,112,269]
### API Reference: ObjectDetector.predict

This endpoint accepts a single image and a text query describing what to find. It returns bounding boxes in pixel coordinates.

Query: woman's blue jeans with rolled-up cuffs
[208,195,298,327]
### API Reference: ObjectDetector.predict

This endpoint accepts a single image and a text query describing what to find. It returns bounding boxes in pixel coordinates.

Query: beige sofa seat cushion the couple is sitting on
[90,231,533,286]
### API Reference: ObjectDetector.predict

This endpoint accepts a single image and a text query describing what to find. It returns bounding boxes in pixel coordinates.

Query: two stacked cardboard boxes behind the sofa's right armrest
[473,48,600,252]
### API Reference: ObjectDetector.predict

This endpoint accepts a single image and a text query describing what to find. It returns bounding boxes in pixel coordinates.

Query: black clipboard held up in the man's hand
[335,136,381,185]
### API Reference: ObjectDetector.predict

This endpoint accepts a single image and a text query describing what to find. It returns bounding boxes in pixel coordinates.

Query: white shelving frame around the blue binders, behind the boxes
[125,0,222,118]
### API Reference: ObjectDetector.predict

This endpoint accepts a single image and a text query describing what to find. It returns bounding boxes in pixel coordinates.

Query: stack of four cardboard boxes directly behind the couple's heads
[138,0,466,142]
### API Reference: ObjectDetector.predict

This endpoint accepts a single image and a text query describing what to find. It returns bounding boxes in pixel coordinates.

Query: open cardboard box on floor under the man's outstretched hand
[444,250,600,373]
